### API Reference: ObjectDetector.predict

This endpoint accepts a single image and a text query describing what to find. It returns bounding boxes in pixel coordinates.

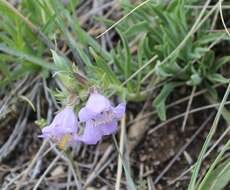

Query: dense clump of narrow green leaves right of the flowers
[113,0,229,120]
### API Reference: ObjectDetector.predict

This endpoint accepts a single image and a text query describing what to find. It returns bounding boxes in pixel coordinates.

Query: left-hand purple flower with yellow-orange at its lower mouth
[39,107,78,146]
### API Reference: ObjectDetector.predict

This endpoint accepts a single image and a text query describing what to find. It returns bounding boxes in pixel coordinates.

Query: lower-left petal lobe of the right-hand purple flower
[77,121,102,144]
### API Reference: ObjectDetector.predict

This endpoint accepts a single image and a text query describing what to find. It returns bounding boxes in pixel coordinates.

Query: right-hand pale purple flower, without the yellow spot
[76,92,126,144]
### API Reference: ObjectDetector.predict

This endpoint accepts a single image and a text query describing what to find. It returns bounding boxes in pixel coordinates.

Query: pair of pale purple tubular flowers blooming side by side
[40,92,126,148]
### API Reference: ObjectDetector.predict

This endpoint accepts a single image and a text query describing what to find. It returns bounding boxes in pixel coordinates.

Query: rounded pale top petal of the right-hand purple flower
[86,93,111,114]
